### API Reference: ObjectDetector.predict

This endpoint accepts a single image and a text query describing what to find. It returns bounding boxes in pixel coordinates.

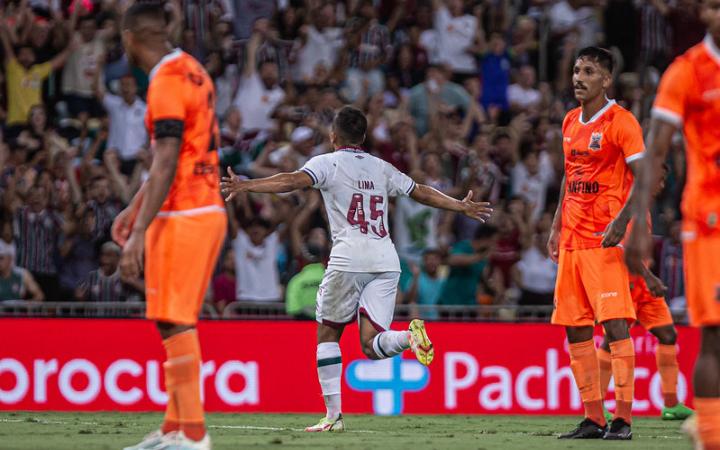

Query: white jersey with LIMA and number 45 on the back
[301,148,415,273]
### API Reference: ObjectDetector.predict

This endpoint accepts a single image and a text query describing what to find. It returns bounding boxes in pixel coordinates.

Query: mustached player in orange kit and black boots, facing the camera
[548,47,645,440]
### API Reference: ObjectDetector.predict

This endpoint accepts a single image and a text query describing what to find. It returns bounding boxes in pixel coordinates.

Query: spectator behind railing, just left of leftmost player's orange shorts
[75,242,145,302]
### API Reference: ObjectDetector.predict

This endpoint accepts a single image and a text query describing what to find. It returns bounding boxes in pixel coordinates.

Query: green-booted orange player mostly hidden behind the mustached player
[598,165,693,420]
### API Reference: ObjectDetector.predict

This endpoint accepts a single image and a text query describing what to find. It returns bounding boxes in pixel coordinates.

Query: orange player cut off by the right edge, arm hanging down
[625,0,720,450]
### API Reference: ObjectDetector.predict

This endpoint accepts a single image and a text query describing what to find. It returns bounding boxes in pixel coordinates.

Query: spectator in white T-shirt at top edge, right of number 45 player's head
[433,0,482,82]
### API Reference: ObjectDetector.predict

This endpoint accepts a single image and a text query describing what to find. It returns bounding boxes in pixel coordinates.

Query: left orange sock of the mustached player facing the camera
[570,339,606,426]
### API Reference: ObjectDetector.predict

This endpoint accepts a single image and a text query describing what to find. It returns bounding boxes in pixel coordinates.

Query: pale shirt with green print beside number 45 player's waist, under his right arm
[393,197,440,264]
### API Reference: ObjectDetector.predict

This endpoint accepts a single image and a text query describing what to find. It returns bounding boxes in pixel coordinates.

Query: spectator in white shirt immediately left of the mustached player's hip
[512,231,557,316]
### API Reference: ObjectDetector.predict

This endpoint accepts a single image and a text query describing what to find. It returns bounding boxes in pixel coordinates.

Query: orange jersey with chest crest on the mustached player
[560,100,645,250]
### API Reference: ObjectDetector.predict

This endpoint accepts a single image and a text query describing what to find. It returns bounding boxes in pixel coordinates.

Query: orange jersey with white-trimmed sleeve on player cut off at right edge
[652,36,720,234]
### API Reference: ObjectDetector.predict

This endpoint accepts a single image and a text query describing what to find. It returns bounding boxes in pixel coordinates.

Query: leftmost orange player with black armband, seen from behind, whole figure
[113,3,227,450]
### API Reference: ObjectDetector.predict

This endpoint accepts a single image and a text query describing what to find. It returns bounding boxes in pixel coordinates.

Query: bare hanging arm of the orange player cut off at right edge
[625,118,676,275]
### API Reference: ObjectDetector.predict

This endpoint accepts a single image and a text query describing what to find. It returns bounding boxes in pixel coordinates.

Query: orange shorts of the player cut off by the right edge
[682,224,720,327]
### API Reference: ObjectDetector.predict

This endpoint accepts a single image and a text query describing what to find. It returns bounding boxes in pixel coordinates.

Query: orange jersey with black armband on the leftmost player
[145,50,224,216]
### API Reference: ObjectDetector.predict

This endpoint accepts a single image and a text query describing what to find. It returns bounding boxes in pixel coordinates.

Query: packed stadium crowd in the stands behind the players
[0,0,704,318]
